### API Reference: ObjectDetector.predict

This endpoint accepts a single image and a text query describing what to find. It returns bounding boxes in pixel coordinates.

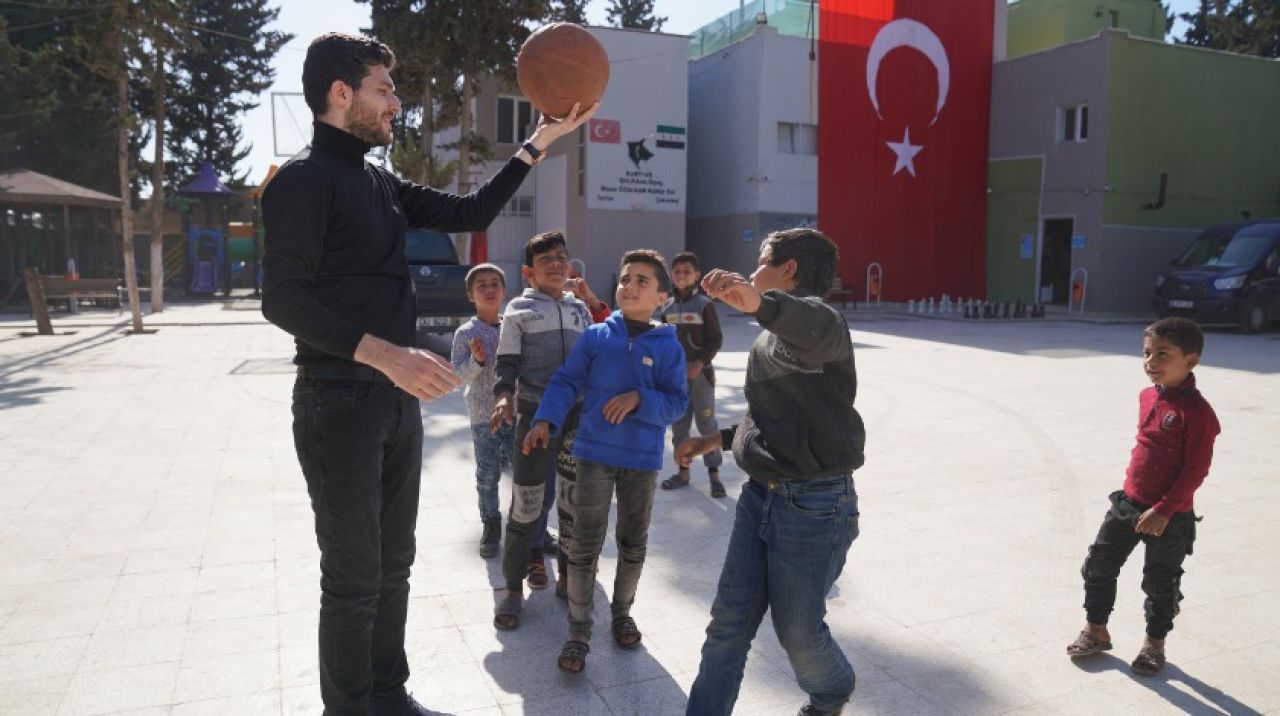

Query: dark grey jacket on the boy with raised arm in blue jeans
[722,291,867,482]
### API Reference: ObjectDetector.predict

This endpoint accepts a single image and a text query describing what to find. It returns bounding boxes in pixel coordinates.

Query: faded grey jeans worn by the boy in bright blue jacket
[561,459,658,642]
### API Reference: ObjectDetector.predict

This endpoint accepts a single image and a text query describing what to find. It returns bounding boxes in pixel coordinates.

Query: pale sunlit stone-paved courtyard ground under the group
[0,301,1280,716]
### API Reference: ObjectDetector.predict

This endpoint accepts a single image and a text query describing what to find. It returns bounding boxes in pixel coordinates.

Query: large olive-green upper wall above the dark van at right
[1103,35,1280,228]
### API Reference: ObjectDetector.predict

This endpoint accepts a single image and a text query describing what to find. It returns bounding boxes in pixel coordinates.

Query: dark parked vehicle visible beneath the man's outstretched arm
[404,229,475,343]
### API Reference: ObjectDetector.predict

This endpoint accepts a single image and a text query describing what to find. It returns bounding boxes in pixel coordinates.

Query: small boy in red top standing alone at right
[1066,318,1221,676]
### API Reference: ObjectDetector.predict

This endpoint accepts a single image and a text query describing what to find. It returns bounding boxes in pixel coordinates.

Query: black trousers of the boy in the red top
[1080,491,1197,639]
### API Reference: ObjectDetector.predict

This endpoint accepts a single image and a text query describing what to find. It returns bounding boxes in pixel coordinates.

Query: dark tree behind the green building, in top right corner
[1175,0,1280,58]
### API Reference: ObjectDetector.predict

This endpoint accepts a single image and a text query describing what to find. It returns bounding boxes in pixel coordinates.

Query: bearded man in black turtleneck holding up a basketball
[262,33,595,716]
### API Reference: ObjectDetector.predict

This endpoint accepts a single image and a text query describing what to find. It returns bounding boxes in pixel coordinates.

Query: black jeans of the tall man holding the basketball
[293,378,422,716]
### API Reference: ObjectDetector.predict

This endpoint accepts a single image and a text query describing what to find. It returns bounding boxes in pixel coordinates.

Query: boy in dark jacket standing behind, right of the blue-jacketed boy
[662,251,724,497]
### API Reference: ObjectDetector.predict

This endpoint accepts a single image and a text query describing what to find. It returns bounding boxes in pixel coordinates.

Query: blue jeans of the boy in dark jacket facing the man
[686,475,858,716]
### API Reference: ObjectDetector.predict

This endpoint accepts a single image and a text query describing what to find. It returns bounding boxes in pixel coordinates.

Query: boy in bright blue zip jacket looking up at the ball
[521,250,689,674]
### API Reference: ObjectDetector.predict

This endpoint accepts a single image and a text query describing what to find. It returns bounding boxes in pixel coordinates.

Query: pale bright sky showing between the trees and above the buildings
[235,0,1196,183]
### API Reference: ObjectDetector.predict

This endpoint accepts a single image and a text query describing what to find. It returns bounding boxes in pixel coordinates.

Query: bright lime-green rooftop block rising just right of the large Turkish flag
[1007,0,1165,58]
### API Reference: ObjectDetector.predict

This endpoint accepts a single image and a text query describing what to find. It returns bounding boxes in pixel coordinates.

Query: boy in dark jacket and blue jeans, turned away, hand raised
[676,229,867,716]
